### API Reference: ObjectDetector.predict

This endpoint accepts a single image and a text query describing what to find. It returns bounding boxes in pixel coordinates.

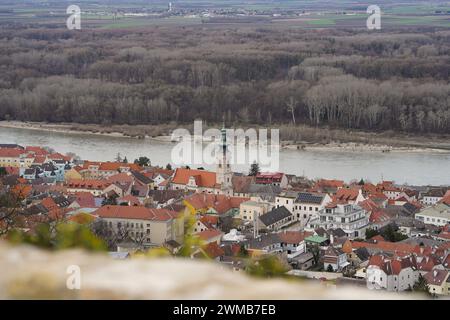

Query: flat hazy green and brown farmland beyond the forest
[0,0,450,29]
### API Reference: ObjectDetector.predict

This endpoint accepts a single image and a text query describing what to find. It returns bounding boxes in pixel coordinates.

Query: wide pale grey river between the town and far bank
[0,127,450,185]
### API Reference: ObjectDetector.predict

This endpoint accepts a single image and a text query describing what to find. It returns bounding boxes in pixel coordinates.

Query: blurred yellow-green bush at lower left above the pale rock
[7,223,107,251]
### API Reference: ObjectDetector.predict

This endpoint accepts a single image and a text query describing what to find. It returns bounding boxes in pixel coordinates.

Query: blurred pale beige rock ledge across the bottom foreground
[0,242,415,299]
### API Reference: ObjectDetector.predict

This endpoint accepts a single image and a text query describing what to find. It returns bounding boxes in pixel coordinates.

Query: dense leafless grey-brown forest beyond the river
[0,25,450,133]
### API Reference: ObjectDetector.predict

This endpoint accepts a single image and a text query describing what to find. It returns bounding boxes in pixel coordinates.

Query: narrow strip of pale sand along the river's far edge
[0,121,450,153]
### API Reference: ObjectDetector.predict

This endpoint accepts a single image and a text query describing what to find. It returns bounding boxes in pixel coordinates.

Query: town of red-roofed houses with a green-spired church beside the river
[0,140,450,297]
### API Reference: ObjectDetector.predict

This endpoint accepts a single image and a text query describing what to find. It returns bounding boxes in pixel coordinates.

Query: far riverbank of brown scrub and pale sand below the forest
[0,121,450,153]
